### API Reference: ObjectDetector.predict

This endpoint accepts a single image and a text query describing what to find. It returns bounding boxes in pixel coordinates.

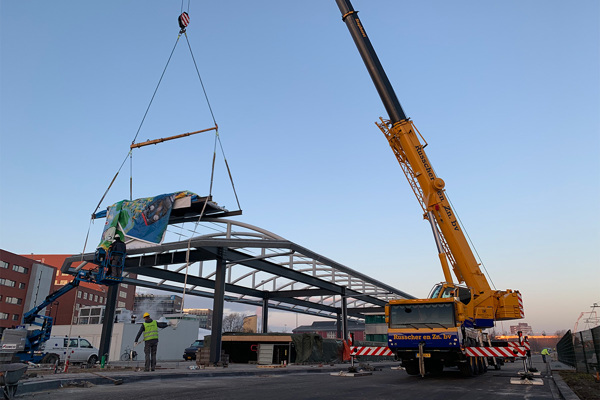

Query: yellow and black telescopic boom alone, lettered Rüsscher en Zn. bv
[336,0,504,296]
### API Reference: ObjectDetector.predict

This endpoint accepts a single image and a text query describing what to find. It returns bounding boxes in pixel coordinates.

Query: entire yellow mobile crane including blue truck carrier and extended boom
[336,0,524,376]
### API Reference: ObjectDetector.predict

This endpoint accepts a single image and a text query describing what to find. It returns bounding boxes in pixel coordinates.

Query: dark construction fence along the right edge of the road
[556,326,600,373]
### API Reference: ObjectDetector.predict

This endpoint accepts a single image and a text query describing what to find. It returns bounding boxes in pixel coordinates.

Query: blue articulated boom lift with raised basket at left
[0,248,126,364]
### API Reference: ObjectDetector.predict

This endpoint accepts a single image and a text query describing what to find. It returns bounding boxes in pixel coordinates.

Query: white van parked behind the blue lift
[40,336,98,365]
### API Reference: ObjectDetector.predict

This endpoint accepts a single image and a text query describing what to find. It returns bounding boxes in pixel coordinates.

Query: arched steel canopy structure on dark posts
[61,217,414,362]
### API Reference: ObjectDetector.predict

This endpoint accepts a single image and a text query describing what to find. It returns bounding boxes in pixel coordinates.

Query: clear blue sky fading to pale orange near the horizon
[0,0,600,332]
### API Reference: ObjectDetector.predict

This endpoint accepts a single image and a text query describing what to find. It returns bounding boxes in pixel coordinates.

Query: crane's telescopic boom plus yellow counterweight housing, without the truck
[336,0,523,327]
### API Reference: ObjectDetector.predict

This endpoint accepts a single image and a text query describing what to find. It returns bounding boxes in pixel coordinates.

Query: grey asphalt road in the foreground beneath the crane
[19,363,558,400]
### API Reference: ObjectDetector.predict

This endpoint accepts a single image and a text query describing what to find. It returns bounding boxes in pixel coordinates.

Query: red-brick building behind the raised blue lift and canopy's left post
[23,254,135,325]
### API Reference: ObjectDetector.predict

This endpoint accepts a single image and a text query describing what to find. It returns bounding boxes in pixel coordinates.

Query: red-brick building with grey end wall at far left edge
[0,250,56,331]
